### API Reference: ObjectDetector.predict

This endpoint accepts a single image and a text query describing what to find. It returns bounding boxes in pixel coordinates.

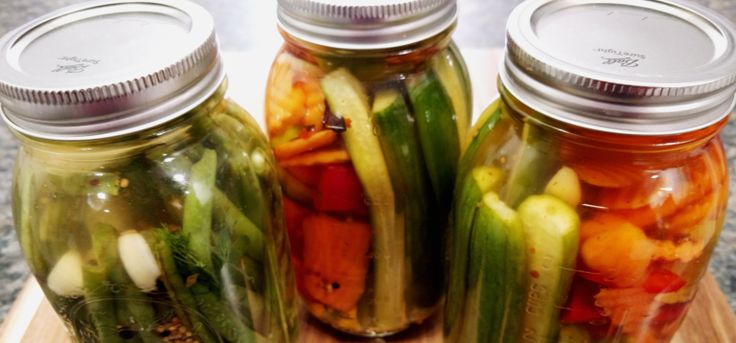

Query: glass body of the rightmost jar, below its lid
[445,85,728,342]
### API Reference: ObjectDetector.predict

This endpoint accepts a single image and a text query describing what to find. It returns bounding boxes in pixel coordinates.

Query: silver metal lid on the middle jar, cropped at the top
[278,0,457,50]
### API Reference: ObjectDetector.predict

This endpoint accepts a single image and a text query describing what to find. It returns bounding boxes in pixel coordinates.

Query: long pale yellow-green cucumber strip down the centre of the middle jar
[321,68,406,331]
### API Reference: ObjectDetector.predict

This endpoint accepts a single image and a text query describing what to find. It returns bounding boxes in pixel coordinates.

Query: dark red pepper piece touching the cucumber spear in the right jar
[560,276,606,324]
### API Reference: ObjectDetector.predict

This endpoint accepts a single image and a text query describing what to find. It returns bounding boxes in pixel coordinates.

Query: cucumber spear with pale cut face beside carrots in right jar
[518,195,580,342]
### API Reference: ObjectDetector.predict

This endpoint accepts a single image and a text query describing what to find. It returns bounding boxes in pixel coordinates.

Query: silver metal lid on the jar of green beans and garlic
[0,0,224,140]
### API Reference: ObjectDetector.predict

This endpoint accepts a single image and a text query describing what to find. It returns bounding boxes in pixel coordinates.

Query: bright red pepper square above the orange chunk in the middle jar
[314,164,368,216]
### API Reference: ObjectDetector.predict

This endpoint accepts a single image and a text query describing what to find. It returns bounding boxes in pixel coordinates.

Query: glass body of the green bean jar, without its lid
[13,85,296,342]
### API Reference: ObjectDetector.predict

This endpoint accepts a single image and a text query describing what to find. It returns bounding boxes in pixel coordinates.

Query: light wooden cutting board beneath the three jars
[0,274,736,343]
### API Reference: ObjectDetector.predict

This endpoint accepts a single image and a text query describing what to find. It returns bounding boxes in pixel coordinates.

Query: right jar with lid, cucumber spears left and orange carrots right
[445,0,736,342]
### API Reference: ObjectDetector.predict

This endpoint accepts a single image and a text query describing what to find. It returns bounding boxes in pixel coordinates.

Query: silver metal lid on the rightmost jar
[500,0,736,135]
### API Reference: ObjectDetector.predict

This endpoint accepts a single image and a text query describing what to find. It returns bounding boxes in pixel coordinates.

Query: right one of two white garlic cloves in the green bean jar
[118,231,161,292]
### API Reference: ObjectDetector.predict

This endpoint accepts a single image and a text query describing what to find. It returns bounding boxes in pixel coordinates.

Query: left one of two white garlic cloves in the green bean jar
[47,251,84,297]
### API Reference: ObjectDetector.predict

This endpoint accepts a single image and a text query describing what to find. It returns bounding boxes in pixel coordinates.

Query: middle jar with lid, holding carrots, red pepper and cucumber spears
[266,0,471,336]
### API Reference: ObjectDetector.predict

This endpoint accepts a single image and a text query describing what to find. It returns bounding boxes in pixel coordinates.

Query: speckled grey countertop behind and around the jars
[0,0,736,322]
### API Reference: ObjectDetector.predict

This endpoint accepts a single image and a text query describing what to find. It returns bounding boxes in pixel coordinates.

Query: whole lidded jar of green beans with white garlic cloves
[0,1,297,342]
